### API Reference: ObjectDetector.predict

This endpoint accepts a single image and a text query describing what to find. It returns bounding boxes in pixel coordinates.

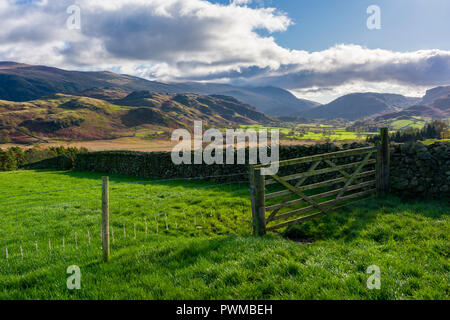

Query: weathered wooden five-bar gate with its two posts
[250,128,389,235]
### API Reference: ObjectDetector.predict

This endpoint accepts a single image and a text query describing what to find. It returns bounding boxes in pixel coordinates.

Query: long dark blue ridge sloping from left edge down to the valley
[0,62,318,116]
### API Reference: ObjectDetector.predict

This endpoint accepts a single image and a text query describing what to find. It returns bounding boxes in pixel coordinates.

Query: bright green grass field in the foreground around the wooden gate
[0,171,450,299]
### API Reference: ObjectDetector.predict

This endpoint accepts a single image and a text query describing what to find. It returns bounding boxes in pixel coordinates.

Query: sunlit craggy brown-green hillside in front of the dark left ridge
[0,91,273,143]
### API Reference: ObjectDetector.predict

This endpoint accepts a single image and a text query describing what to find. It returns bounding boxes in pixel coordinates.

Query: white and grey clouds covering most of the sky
[0,0,450,99]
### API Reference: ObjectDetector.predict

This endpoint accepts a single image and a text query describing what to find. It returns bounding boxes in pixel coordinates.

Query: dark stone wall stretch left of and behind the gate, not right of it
[75,143,367,183]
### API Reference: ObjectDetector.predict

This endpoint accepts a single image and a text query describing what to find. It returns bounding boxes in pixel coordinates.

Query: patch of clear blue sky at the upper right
[211,0,450,51]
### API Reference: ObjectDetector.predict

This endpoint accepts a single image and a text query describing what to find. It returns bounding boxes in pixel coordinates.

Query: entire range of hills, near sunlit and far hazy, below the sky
[0,62,450,143]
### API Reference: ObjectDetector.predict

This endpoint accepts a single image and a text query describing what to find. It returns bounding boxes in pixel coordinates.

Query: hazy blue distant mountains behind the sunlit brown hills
[0,62,448,121]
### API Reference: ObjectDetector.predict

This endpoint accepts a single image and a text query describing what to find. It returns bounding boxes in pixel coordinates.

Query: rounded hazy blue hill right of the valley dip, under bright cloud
[300,92,420,121]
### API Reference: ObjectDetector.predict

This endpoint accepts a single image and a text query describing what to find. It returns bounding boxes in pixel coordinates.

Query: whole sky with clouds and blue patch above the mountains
[0,0,450,103]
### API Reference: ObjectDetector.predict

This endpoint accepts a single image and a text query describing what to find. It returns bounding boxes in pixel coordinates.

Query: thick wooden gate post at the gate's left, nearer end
[250,166,266,236]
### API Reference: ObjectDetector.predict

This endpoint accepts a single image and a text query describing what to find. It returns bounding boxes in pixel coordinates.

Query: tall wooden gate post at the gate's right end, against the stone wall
[376,128,390,195]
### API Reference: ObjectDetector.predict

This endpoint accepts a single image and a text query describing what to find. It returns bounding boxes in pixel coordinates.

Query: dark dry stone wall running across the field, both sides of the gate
[17,142,450,199]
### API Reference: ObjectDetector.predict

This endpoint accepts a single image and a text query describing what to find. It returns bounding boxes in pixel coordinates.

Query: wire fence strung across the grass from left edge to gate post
[0,174,252,268]
